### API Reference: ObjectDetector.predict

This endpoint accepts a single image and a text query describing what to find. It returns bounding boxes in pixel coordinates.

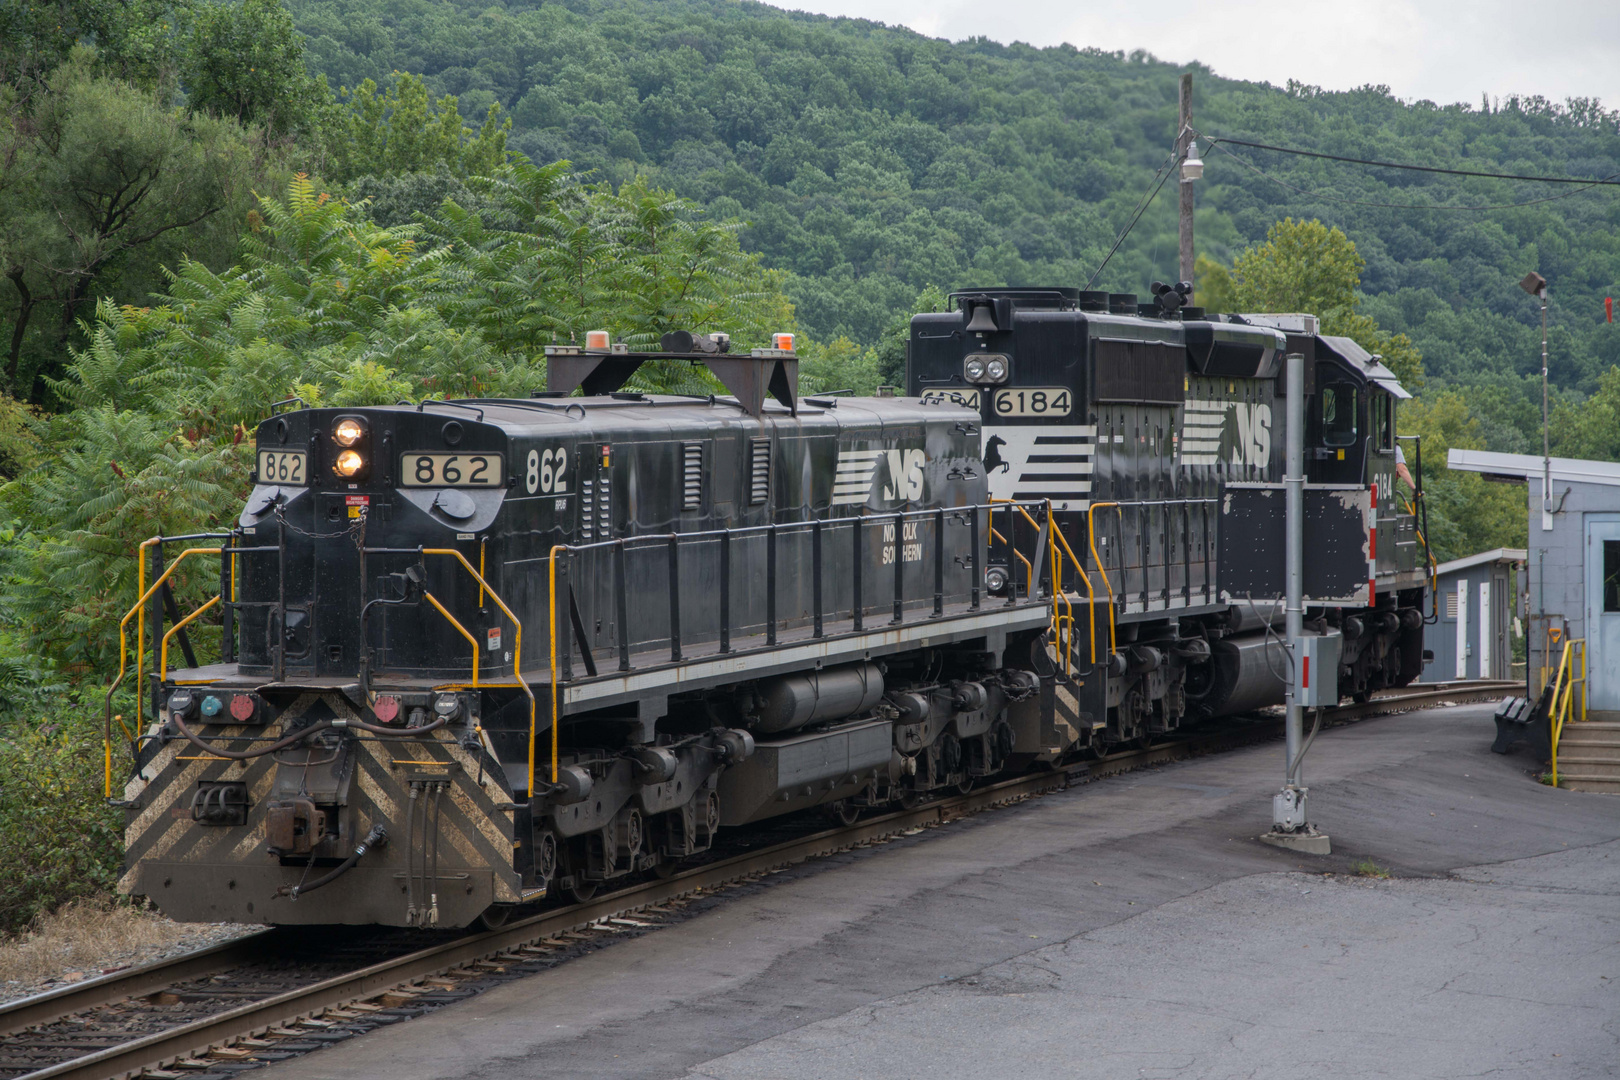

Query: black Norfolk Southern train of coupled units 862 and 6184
[109,290,1422,926]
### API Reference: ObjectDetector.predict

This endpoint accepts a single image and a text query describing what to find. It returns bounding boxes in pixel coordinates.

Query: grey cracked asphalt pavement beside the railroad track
[258,704,1620,1080]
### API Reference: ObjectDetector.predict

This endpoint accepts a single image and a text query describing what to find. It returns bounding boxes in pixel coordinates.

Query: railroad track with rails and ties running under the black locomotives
[0,682,1520,1080]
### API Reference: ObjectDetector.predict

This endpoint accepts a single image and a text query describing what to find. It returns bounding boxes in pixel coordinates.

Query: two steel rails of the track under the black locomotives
[0,680,1521,1080]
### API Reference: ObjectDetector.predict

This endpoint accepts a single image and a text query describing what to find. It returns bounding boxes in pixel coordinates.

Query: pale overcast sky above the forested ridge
[771,0,1620,108]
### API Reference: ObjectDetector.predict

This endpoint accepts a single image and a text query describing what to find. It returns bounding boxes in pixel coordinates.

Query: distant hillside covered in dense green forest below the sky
[290,0,1620,408]
